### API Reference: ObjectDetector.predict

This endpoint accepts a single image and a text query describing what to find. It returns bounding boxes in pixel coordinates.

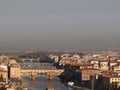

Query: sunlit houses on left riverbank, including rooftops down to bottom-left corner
[0,55,21,90]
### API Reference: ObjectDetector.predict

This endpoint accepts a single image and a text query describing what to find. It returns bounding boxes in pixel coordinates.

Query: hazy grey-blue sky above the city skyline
[0,0,120,50]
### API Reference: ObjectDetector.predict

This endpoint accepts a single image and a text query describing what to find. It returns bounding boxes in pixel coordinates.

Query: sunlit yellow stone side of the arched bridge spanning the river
[21,69,64,80]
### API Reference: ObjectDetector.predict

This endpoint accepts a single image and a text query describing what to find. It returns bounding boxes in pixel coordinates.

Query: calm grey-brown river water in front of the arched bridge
[21,76,71,90]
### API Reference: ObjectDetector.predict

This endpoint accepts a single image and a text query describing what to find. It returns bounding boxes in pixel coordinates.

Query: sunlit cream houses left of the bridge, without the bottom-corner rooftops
[0,55,21,79]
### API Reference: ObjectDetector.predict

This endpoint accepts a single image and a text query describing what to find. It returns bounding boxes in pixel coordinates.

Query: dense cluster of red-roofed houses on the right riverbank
[50,51,120,90]
